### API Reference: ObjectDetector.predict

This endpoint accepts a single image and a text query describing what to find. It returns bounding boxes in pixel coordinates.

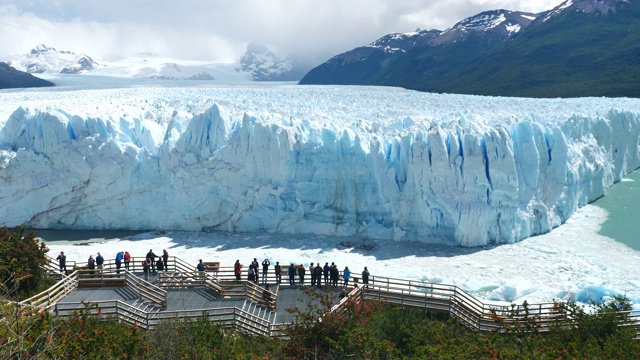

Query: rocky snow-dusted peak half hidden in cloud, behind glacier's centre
[236,43,313,81]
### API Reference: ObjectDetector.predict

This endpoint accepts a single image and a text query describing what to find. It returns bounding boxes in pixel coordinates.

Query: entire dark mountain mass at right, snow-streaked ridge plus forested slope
[300,0,640,97]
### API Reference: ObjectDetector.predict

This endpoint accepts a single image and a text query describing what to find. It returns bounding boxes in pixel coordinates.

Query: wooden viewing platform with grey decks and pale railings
[13,257,640,338]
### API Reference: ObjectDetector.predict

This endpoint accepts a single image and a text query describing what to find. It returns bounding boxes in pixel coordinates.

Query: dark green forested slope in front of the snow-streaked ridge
[428,1,640,97]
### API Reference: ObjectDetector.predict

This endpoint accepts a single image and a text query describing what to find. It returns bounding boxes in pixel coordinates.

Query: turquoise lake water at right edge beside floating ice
[593,170,640,251]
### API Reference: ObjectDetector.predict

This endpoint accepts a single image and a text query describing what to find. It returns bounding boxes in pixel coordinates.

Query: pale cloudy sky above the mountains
[0,0,562,62]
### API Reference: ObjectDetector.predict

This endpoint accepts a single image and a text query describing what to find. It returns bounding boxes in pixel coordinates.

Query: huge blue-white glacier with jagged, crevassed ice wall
[0,85,640,247]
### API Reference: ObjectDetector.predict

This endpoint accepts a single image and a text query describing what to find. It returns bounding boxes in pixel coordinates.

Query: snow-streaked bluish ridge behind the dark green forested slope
[300,10,536,86]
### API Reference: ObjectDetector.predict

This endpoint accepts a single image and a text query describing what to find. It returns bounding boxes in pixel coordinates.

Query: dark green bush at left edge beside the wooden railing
[0,226,50,299]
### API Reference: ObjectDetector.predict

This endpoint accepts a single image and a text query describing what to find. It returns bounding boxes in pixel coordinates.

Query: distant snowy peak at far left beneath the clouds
[10,44,100,74]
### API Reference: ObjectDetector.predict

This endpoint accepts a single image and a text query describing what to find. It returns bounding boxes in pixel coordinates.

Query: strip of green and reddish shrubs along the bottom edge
[0,290,640,359]
